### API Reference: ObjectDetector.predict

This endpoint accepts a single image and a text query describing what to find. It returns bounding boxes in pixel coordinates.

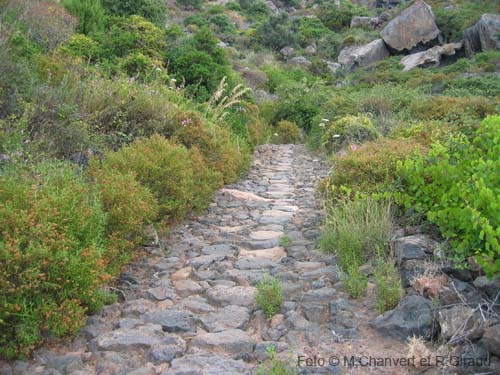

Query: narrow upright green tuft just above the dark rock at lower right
[374,255,403,313]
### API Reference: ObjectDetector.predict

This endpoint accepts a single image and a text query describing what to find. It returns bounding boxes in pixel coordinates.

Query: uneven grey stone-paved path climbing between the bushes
[0,145,412,375]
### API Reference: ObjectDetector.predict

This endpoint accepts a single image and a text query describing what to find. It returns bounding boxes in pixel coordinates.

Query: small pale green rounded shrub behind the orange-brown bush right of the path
[322,115,380,152]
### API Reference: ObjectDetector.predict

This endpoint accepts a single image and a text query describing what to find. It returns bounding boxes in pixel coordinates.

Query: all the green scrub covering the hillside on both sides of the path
[0,0,500,362]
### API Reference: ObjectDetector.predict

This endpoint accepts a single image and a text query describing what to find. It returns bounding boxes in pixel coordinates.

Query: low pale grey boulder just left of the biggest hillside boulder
[338,39,389,70]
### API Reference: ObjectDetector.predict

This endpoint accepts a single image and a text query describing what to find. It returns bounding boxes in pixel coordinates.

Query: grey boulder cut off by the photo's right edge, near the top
[463,14,500,57]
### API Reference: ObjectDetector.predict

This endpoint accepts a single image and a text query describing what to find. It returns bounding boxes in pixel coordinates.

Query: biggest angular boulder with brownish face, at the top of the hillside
[380,0,441,52]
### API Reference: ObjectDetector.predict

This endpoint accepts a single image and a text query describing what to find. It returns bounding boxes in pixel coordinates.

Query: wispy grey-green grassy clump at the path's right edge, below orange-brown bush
[321,198,393,273]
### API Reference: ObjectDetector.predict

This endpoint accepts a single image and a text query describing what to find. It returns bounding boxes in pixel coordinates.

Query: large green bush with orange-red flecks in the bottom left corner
[0,163,106,359]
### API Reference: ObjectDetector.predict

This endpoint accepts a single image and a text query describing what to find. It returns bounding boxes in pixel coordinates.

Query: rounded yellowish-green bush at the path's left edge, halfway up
[101,135,218,220]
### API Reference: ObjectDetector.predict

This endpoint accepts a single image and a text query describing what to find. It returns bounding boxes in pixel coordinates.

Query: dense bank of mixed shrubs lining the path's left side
[0,0,267,358]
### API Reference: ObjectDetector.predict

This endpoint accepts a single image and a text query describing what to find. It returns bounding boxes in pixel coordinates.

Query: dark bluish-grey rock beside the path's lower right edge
[370,295,435,341]
